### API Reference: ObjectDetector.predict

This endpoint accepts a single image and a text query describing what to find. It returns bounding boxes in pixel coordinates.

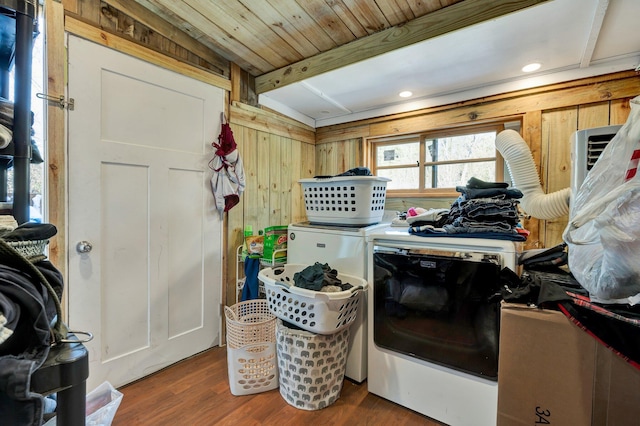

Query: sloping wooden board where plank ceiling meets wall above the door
[102,0,229,72]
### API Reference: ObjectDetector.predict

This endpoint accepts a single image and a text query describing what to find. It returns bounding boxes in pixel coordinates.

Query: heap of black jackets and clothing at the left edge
[0,223,63,425]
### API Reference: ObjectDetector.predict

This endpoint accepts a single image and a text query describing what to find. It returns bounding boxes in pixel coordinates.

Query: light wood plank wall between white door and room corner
[225,103,316,305]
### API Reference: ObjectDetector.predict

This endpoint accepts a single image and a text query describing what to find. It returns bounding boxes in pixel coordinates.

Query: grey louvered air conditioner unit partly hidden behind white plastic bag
[571,125,622,194]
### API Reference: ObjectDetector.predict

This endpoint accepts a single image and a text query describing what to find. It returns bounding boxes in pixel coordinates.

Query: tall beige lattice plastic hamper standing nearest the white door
[224,299,278,395]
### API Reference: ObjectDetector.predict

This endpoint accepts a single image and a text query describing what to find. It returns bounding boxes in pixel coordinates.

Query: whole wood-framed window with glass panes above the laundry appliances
[371,125,504,196]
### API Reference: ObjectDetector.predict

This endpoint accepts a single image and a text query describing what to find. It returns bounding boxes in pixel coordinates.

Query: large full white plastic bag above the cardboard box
[563,96,640,305]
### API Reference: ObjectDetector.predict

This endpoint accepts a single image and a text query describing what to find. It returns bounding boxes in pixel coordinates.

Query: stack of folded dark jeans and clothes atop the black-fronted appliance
[409,177,526,241]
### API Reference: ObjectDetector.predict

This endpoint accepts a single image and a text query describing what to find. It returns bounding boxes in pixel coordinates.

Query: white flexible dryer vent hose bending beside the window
[496,129,571,219]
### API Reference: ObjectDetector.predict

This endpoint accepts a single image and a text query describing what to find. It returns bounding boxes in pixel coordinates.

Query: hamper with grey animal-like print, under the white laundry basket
[276,319,349,410]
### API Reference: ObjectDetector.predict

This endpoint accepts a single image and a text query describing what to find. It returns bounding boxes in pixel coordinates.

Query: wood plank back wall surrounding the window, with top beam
[316,71,640,248]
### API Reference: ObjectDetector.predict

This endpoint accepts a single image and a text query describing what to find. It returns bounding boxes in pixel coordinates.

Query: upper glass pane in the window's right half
[427,132,496,161]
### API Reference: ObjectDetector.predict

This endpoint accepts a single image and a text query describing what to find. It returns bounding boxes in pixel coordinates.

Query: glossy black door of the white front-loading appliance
[373,249,501,380]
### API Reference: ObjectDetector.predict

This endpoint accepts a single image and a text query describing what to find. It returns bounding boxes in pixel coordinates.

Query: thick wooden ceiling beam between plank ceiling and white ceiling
[256,0,549,94]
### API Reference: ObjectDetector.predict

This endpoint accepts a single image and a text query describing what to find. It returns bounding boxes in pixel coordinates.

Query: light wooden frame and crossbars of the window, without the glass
[367,122,505,198]
